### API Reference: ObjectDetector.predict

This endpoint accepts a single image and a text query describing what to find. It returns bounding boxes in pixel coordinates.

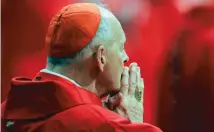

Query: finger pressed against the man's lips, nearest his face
[120,66,129,95]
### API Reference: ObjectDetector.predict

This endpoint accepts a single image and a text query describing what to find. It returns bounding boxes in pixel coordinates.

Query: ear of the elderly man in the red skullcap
[96,45,106,72]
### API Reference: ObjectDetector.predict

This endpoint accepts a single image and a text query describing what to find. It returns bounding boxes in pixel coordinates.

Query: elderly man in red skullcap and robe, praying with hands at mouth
[2,3,161,132]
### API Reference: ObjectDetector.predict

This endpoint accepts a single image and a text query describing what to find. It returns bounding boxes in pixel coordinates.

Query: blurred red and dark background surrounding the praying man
[1,0,214,132]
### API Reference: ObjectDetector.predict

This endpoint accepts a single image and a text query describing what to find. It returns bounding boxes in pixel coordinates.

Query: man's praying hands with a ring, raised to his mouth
[103,63,144,123]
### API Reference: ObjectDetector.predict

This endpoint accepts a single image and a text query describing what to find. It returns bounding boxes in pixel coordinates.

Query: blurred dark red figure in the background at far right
[158,6,214,132]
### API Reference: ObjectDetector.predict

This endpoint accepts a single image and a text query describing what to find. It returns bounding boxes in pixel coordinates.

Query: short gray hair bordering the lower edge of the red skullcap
[47,5,115,66]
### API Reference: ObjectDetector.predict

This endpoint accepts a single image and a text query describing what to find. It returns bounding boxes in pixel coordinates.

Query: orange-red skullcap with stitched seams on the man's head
[45,3,101,58]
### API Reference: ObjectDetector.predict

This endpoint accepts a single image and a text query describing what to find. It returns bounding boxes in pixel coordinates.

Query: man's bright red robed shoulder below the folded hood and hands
[47,104,161,132]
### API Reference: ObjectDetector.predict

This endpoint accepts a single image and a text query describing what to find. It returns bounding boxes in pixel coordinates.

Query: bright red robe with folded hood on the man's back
[2,72,161,132]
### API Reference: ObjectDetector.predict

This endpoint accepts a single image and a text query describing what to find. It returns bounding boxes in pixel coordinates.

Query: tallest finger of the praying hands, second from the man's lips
[128,63,137,96]
